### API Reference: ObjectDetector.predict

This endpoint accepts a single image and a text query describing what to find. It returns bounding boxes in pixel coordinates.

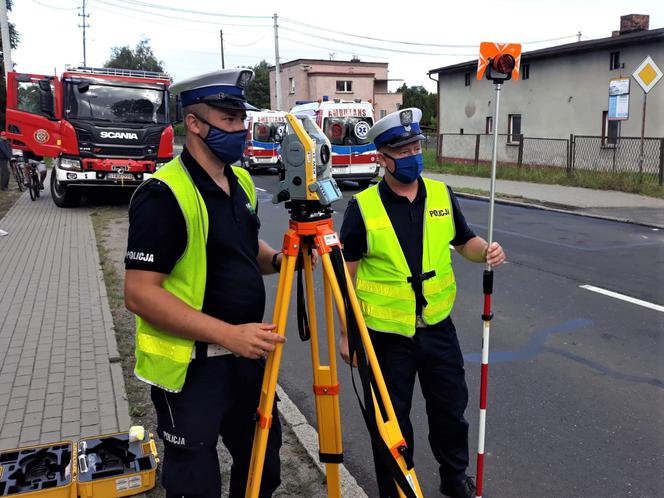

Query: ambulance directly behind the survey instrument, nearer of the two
[290,99,378,188]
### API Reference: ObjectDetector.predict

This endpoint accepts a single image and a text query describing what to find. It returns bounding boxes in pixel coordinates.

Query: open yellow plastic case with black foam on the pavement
[0,432,159,498]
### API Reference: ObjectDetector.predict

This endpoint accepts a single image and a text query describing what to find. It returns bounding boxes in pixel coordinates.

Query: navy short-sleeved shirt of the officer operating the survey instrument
[125,148,265,325]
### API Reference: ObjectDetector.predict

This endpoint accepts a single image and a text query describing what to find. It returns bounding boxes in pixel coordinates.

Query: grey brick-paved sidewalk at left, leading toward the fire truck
[0,181,130,449]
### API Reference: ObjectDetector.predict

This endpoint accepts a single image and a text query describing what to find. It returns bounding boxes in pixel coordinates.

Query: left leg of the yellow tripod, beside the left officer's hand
[245,254,297,498]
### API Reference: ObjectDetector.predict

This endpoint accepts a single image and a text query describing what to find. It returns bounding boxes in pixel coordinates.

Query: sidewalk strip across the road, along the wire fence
[425,172,664,229]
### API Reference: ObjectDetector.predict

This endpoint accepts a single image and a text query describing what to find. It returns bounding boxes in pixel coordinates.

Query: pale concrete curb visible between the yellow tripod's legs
[277,385,367,498]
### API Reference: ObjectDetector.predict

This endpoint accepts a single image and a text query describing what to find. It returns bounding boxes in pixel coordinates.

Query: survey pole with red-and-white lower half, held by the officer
[475,82,502,498]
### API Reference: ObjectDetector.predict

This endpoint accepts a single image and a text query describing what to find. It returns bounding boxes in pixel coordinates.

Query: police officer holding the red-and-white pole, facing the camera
[340,108,505,498]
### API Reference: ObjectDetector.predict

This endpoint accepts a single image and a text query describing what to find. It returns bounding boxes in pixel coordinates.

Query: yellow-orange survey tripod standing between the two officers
[245,213,422,498]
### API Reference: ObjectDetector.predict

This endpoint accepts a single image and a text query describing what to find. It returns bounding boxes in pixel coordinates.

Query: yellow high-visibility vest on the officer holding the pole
[355,178,456,337]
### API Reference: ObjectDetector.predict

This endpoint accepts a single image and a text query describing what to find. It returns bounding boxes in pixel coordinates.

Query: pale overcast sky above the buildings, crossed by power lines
[9,0,664,91]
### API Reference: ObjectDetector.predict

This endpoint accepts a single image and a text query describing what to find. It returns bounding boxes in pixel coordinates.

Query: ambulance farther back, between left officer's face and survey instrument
[242,109,286,171]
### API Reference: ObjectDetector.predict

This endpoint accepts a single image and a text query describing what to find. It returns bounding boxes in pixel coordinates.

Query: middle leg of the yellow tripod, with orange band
[304,251,343,498]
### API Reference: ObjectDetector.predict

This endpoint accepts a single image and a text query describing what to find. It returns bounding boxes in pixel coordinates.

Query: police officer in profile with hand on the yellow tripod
[125,69,284,498]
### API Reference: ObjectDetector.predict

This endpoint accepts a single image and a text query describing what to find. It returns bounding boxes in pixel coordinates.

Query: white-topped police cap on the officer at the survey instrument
[170,69,257,111]
